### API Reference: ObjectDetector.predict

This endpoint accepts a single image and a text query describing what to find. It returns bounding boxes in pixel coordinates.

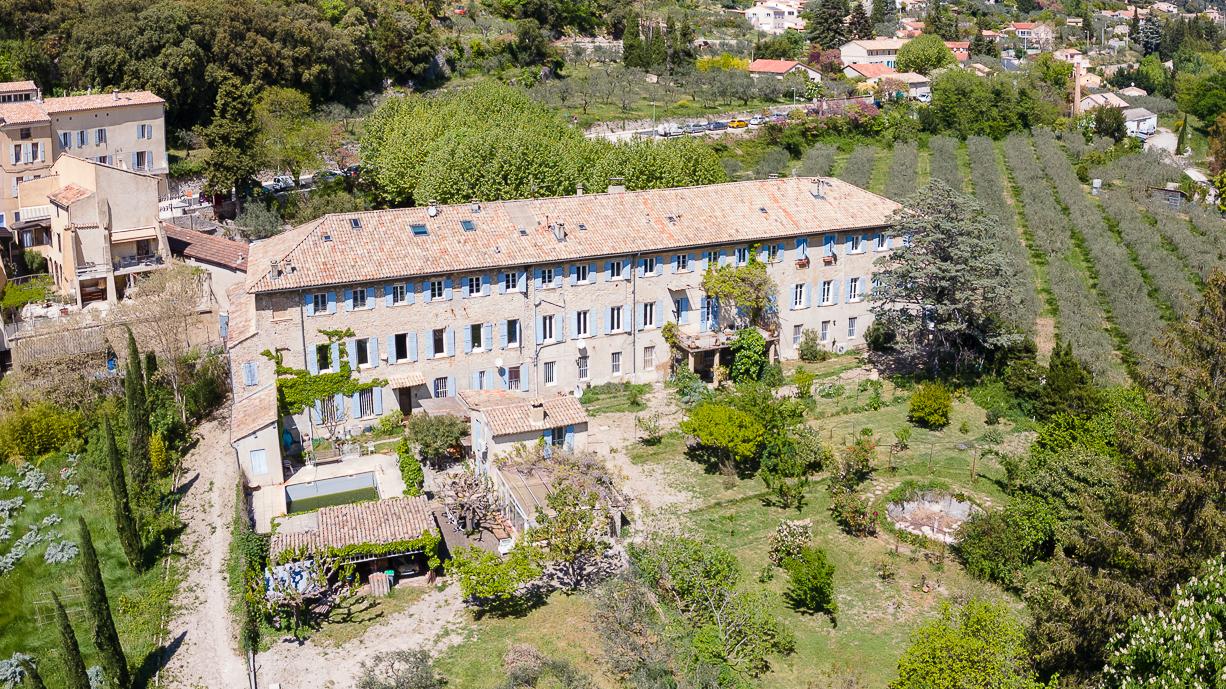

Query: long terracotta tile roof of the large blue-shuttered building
[246,178,899,293]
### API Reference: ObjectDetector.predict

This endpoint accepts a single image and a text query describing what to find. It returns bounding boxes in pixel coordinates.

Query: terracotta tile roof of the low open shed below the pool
[268,495,438,560]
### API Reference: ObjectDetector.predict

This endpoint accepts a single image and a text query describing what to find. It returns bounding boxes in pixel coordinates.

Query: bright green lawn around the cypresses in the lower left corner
[0,456,179,687]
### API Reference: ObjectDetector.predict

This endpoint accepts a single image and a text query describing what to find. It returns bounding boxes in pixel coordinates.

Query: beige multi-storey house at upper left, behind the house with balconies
[0,81,169,234]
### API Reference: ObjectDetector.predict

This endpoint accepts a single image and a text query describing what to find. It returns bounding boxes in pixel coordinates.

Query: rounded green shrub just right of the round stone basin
[955,498,1057,587]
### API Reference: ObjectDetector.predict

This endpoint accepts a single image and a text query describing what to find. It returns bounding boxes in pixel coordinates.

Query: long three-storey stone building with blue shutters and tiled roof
[227,178,897,477]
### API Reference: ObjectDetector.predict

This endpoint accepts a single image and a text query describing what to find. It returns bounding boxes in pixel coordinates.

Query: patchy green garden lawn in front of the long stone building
[440,370,1026,689]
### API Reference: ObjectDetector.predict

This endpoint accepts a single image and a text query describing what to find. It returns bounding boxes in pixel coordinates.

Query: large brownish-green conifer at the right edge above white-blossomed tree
[1026,271,1226,683]
